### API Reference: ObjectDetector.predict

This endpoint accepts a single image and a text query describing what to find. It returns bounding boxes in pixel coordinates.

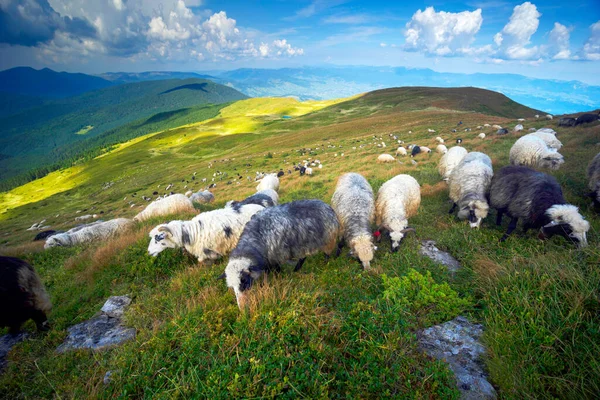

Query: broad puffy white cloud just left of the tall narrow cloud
[404,7,487,56]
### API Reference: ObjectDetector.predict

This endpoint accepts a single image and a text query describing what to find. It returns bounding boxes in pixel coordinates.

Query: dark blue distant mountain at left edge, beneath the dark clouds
[0,67,113,98]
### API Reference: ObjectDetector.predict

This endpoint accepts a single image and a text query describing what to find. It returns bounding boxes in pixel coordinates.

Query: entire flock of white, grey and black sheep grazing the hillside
[0,115,600,332]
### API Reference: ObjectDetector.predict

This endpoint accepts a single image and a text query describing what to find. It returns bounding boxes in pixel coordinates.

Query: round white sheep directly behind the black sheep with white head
[509,133,564,170]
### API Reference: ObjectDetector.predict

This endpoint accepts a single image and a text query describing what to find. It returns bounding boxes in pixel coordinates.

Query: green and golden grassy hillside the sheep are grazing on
[0,90,600,398]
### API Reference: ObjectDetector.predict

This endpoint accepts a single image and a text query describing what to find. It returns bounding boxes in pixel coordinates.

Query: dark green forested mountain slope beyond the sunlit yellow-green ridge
[0,79,246,186]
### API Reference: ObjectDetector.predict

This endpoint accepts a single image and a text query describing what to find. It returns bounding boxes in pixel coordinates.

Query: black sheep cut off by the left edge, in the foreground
[0,256,52,335]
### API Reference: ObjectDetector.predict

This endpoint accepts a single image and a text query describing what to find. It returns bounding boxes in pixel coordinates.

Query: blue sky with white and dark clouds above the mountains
[0,0,600,85]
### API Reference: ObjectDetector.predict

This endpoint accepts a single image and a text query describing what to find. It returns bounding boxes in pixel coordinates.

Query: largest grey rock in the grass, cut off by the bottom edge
[417,317,497,400]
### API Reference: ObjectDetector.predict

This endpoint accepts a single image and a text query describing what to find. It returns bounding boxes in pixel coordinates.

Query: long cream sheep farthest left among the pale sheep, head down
[44,218,133,249]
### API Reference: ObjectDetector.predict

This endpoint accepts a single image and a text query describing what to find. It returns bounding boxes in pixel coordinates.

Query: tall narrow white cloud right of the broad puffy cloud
[494,1,542,60]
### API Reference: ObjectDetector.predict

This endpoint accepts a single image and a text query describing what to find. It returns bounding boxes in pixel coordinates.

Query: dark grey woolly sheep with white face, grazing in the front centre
[219,200,340,309]
